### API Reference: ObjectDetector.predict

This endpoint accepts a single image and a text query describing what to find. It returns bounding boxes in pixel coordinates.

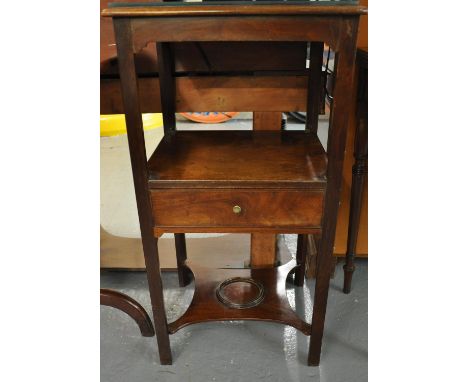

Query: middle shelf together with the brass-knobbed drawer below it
[148,131,327,235]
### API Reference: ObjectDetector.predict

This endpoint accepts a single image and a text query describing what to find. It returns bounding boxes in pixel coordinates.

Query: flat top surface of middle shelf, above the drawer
[148,131,327,189]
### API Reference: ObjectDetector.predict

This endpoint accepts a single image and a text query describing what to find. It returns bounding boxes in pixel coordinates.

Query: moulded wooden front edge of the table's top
[101,3,367,17]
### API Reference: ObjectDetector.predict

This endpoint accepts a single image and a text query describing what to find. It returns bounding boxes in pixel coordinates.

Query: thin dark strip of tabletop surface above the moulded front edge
[109,0,359,8]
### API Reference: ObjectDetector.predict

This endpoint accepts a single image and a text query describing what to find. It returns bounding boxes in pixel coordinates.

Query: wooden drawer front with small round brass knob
[151,189,323,228]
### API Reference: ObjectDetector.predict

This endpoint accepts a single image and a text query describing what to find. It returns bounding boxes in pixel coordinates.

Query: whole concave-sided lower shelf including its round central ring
[169,261,311,335]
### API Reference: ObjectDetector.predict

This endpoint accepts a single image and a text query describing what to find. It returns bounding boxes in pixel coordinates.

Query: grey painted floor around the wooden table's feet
[101,260,367,382]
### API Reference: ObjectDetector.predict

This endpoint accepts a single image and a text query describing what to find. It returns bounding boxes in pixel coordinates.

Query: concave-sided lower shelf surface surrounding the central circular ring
[169,261,310,335]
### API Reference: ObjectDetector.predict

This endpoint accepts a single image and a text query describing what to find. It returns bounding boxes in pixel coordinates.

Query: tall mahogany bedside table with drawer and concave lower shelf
[102,1,366,365]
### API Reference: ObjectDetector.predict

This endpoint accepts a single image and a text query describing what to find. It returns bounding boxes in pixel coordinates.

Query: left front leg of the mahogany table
[114,19,172,365]
